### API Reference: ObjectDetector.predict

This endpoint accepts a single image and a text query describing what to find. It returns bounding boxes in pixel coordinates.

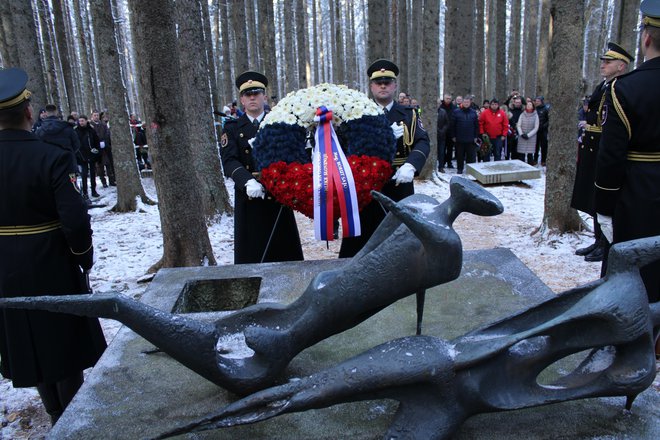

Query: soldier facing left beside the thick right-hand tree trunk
[571,43,634,261]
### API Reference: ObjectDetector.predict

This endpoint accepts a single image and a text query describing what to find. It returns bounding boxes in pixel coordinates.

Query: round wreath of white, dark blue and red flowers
[252,84,396,223]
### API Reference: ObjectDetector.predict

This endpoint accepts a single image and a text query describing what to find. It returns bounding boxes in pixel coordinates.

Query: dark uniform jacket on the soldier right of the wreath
[387,102,431,174]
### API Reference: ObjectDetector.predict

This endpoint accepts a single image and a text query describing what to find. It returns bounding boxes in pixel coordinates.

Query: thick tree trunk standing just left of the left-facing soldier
[542,0,584,233]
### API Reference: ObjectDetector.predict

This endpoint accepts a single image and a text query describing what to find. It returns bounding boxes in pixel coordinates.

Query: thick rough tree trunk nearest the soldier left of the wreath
[129,0,215,270]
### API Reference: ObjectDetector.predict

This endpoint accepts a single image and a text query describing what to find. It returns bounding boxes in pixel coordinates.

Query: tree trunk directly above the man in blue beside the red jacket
[444,0,474,96]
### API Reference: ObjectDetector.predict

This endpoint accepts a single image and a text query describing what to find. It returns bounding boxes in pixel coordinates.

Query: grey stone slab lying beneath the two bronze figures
[49,249,660,440]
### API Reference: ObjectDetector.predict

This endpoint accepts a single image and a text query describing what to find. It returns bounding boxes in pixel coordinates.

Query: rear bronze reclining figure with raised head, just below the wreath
[0,178,503,394]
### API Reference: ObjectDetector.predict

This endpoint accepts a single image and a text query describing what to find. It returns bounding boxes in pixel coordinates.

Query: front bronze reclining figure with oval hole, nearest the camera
[159,237,660,439]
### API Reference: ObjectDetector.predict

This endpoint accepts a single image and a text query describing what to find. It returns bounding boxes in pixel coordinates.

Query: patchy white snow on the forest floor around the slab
[0,165,658,439]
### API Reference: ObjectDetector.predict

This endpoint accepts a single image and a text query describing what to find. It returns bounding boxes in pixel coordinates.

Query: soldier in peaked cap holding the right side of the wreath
[339,60,431,258]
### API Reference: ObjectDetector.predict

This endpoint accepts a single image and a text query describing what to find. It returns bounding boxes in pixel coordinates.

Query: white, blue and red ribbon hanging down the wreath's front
[312,107,360,240]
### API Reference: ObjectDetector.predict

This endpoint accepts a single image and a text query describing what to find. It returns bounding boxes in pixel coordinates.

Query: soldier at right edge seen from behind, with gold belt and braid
[596,0,660,310]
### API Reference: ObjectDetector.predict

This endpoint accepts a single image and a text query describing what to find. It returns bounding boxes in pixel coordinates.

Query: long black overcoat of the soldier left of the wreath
[221,115,303,264]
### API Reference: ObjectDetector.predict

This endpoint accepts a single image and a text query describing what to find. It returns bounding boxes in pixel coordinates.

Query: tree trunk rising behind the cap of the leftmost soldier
[9,0,51,111]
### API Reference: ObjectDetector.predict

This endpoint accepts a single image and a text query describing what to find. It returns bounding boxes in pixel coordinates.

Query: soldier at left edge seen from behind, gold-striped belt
[0,68,105,422]
